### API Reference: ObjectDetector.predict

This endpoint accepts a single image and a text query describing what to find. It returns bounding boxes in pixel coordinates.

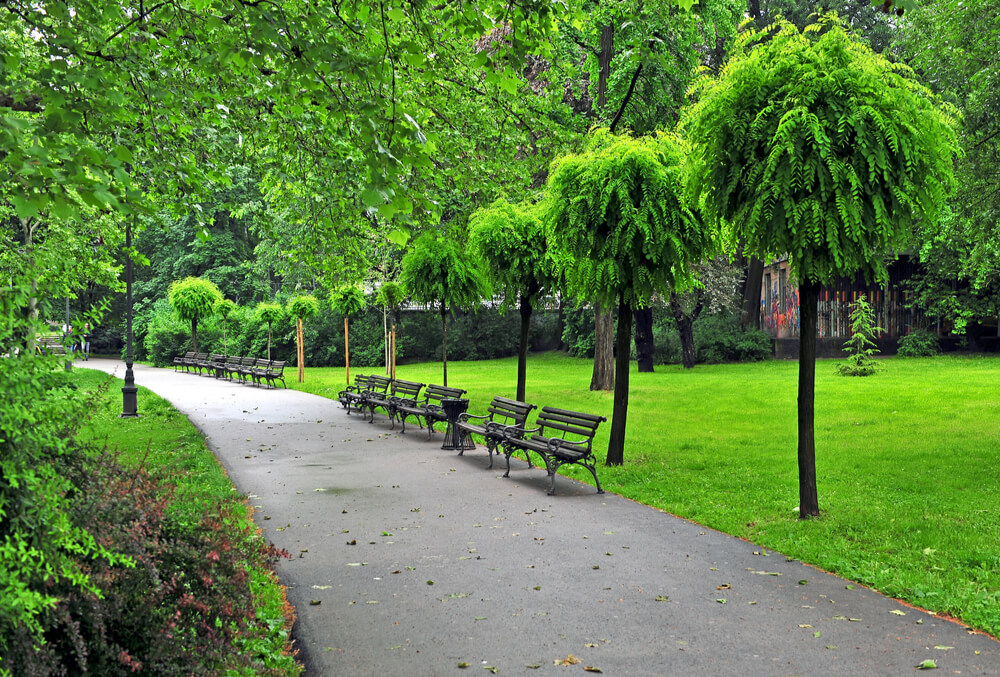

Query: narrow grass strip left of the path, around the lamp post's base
[73,369,301,677]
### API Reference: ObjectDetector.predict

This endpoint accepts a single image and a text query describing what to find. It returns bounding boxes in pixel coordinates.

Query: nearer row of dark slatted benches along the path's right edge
[338,375,607,494]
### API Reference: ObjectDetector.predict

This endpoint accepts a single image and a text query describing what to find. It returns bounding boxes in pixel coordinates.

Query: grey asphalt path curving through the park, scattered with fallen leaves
[86,359,1000,677]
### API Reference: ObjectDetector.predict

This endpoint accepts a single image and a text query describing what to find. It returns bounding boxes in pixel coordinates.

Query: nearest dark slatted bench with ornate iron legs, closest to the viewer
[503,407,607,496]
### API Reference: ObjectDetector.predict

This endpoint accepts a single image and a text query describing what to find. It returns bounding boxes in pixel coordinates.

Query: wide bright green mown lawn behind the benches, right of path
[289,353,1000,636]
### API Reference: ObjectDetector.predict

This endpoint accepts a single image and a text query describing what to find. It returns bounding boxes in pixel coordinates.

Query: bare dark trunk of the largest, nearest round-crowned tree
[799,280,820,519]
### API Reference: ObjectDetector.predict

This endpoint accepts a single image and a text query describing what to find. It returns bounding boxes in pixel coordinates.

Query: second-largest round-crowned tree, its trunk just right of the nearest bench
[548,129,713,465]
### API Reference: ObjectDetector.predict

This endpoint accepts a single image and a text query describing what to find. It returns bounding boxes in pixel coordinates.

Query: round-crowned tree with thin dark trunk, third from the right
[469,198,558,402]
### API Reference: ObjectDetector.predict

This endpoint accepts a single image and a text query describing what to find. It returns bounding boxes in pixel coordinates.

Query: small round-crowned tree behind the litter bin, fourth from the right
[400,231,490,386]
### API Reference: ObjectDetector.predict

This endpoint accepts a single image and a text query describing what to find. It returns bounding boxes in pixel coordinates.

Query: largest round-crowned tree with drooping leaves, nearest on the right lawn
[685,15,955,518]
